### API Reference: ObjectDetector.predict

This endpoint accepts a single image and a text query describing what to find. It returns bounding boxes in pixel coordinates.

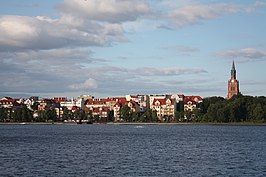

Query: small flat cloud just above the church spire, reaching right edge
[214,48,266,62]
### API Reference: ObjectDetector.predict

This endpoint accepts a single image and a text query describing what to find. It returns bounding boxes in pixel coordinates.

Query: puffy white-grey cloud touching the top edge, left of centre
[57,0,152,23]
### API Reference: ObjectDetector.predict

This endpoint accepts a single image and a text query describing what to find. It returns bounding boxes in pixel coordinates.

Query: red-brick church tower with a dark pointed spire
[227,61,239,99]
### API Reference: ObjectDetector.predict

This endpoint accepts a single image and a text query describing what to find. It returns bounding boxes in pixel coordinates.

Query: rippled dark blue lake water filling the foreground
[0,125,266,177]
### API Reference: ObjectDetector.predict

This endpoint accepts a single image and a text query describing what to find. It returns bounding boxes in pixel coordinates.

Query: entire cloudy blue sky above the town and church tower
[0,0,266,97]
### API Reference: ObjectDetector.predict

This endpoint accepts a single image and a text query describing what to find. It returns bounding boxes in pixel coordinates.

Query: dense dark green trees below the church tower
[196,94,266,122]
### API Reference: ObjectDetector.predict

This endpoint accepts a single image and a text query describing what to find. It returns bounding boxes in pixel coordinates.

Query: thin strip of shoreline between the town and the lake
[0,122,266,126]
